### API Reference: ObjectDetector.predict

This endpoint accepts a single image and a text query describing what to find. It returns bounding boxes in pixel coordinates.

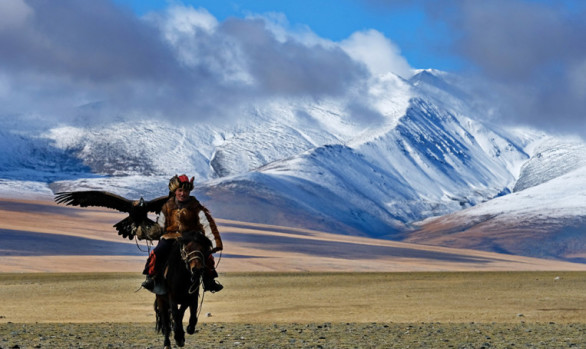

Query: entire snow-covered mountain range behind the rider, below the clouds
[0,70,586,258]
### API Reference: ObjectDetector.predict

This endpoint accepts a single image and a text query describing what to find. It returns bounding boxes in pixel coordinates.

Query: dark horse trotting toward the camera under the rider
[155,232,212,349]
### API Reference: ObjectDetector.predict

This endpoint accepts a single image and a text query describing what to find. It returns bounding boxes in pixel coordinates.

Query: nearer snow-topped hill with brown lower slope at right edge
[404,162,586,263]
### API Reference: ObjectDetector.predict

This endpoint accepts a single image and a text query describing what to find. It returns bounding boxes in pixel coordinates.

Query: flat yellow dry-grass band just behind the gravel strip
[0,272,586,323]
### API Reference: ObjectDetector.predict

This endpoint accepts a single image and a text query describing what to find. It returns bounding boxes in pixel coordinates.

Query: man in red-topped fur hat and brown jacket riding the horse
[142,174,224,293]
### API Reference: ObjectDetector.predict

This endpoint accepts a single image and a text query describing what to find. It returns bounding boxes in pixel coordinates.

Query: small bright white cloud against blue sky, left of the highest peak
[340,29,413,78]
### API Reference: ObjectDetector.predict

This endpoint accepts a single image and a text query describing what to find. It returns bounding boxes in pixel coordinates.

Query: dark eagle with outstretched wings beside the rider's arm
[55,190,169,240]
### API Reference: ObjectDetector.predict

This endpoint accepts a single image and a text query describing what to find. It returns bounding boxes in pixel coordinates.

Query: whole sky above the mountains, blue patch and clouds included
[0,0,586,136]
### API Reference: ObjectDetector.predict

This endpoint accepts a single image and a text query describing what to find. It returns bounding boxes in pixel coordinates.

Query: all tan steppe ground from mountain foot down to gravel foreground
[0,200,586,349]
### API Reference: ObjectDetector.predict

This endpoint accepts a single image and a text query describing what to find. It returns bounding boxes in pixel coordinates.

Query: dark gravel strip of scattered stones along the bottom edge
[0,322,586,349]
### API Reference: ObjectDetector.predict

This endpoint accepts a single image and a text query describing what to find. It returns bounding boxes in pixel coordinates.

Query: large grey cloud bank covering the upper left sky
[0,0,370,122]
